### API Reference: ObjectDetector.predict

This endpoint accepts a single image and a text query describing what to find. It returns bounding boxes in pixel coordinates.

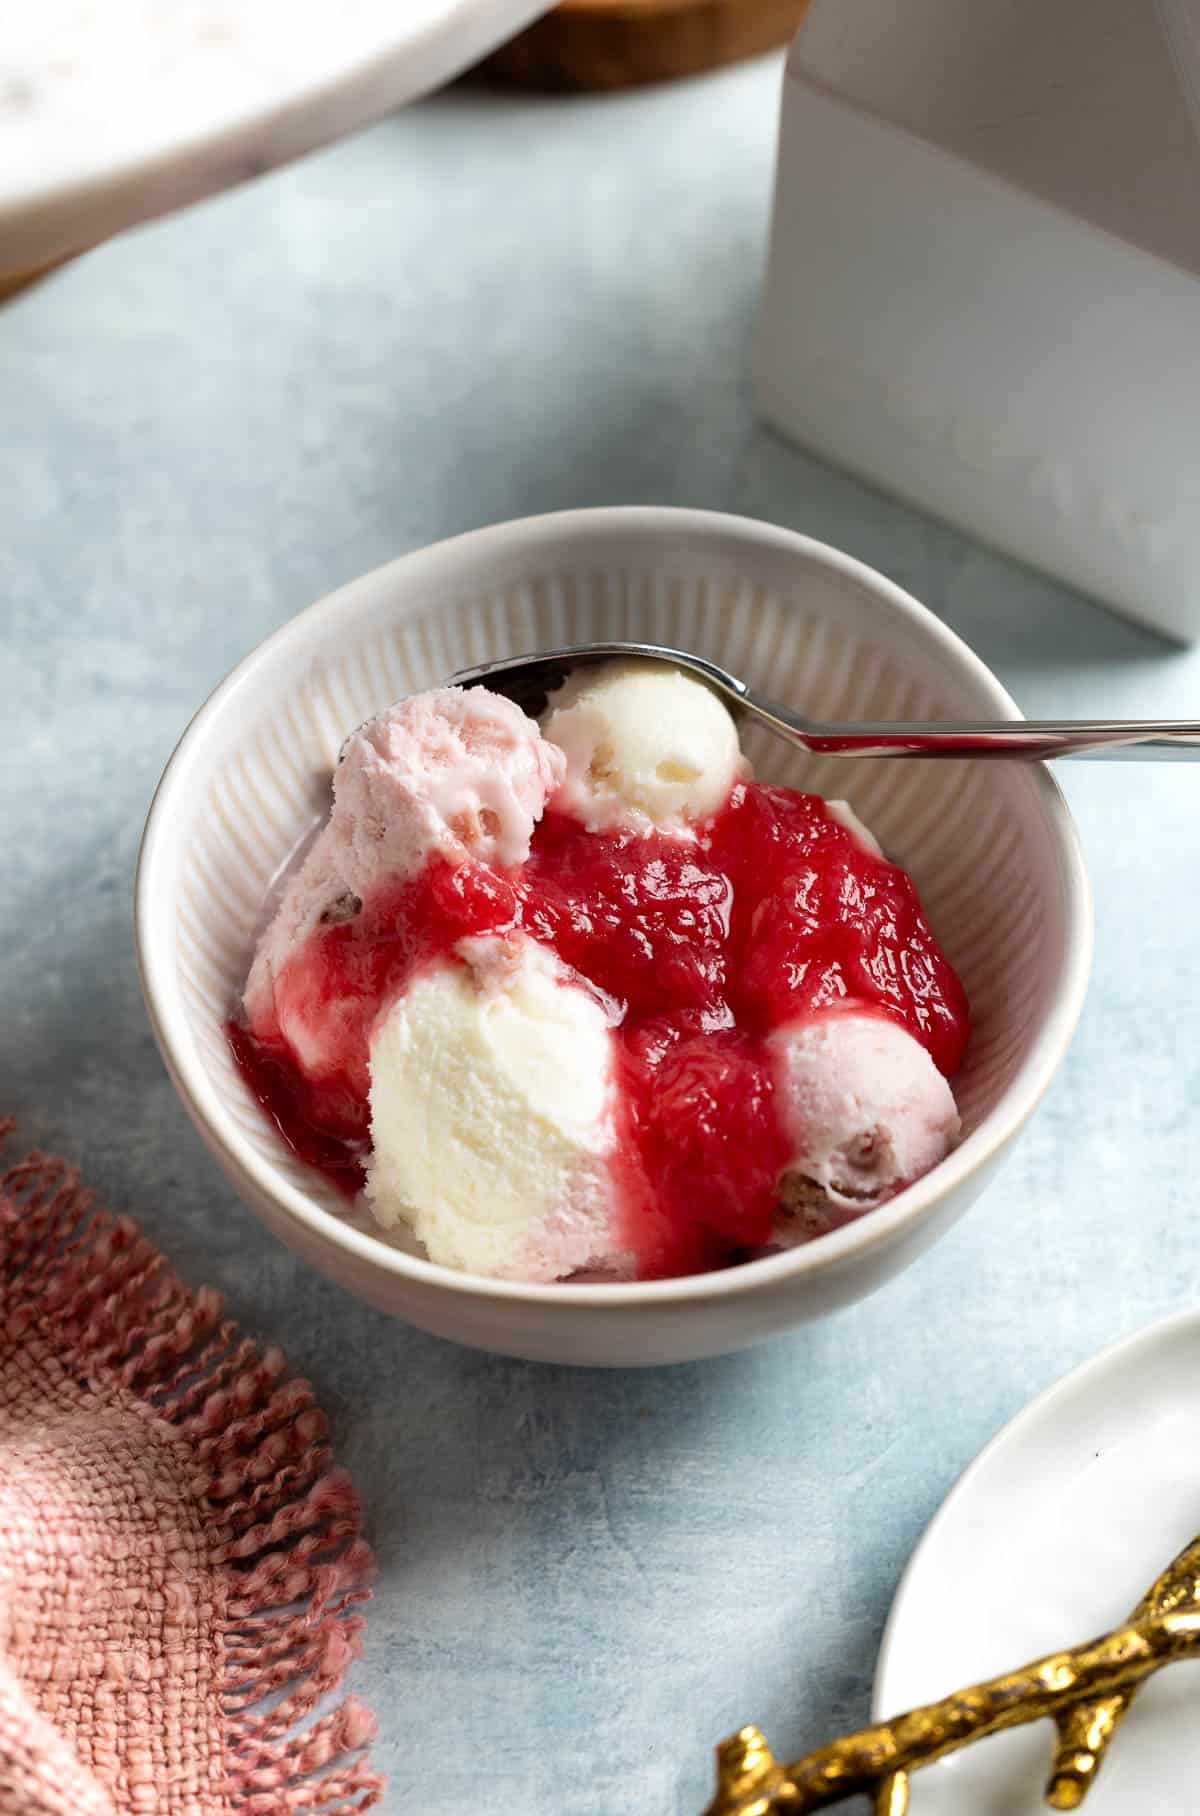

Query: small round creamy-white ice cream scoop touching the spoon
[543,661,748,832]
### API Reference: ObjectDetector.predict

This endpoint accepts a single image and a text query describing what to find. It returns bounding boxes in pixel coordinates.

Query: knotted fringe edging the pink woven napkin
[0,1120,383,1816]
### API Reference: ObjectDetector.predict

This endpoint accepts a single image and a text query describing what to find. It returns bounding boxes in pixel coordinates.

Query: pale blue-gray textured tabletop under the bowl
[0,60,1200,1816]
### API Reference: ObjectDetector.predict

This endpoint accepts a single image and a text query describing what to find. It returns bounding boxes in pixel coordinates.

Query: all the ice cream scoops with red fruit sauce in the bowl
[229,659,969,1282]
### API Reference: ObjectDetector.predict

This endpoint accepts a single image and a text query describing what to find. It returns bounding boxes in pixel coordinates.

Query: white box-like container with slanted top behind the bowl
[753,0,1200,639]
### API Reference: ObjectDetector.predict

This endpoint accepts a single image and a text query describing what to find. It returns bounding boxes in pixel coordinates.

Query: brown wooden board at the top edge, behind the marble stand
[483,0,808,91]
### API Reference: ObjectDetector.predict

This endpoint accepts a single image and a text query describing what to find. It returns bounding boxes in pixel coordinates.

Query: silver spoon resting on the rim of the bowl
[447,643,1200,761]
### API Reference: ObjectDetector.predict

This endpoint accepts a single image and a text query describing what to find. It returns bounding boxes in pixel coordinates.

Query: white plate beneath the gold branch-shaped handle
[875,1311,1200,1816]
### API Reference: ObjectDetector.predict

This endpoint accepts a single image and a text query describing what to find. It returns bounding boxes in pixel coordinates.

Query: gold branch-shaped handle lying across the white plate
[704,1538,1200,1816]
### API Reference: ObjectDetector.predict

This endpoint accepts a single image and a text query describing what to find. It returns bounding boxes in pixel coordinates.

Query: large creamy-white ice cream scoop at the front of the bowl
[367,937,632,1280]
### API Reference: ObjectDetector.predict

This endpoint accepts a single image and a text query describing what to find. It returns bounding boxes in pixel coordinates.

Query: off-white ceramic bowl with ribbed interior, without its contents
[136,508,1091,1366]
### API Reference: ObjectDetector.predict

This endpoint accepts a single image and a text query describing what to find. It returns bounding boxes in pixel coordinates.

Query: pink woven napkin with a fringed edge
[0,1130,383,1816]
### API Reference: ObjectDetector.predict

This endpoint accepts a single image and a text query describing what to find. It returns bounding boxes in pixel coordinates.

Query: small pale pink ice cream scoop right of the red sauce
[770,1008,959,1222]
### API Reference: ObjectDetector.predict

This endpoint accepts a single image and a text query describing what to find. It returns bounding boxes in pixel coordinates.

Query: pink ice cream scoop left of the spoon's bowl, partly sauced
[245,686,566,1046]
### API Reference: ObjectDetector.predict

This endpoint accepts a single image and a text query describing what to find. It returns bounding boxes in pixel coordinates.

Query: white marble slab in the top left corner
[0,0,550,274]
